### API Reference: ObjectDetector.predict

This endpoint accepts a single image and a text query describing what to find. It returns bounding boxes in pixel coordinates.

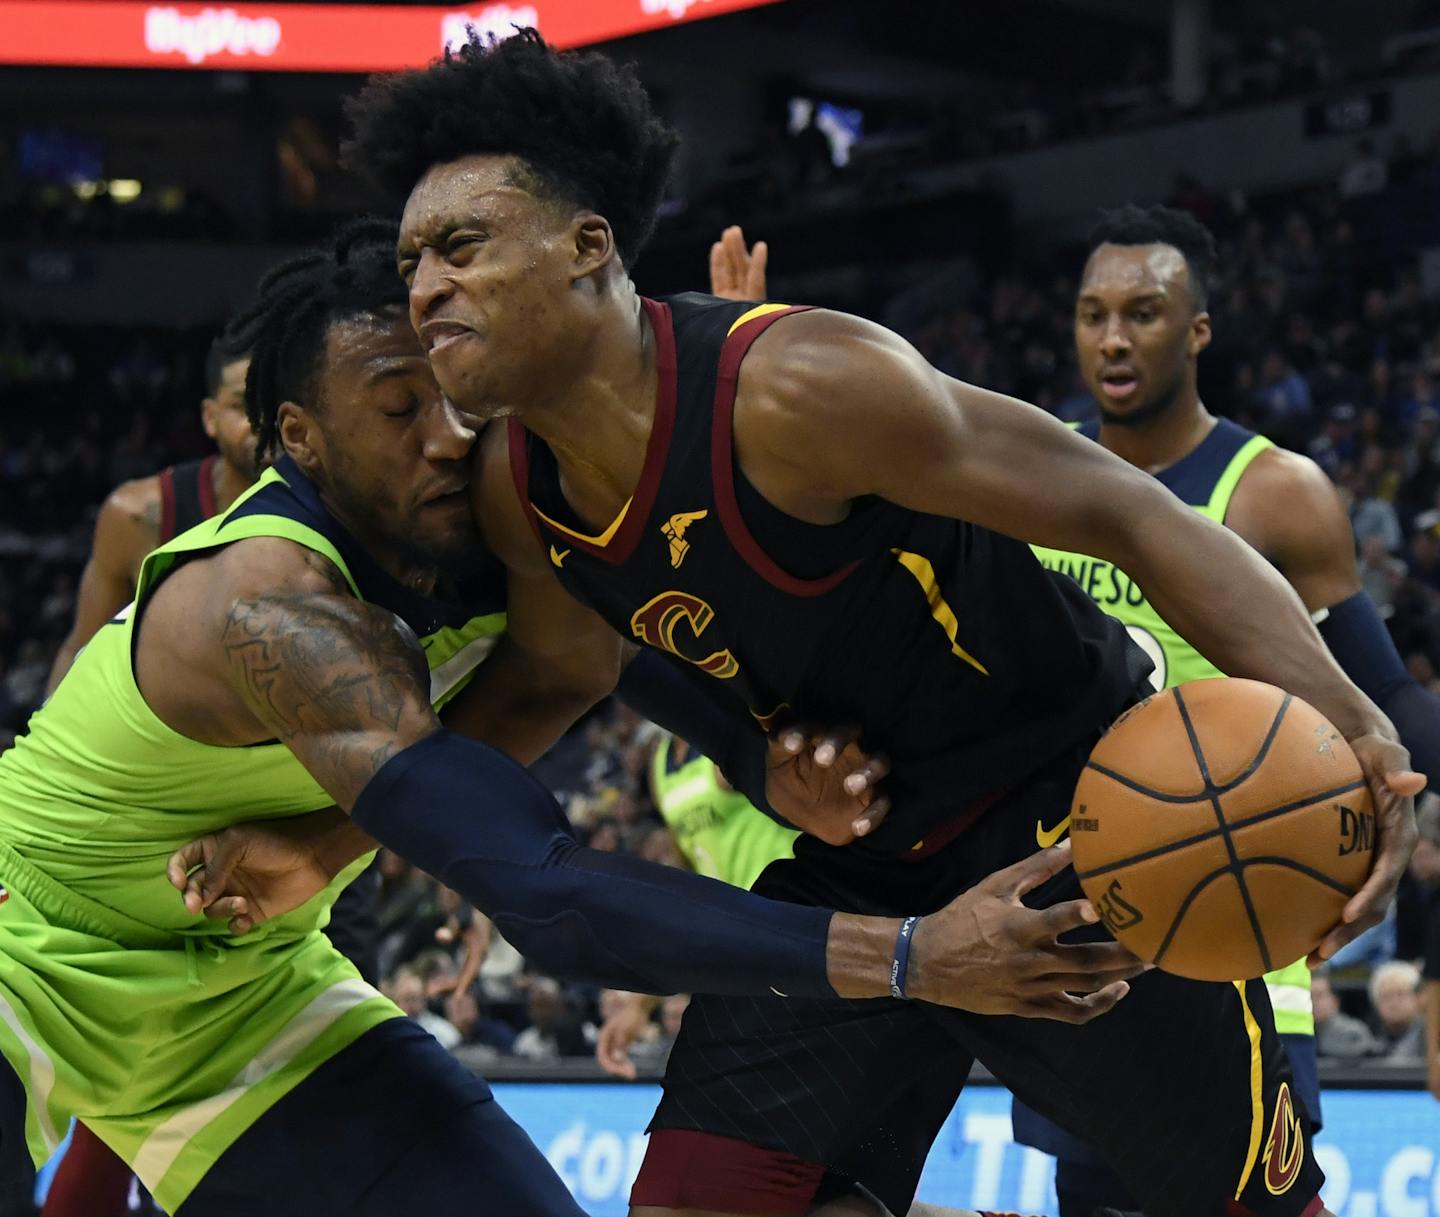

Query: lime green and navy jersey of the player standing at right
[1034,419,1315,1036]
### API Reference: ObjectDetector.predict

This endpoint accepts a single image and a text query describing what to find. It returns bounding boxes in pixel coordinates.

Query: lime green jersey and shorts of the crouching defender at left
[0,461,505,1211]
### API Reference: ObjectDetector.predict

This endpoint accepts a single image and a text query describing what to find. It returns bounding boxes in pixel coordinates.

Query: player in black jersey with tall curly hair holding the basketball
[342,32,1423,1217]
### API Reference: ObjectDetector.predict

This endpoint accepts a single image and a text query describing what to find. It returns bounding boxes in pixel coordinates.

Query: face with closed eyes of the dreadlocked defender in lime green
[286,308,478,566]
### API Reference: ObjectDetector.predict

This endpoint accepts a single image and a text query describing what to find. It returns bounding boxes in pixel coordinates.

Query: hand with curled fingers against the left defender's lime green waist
[166,817,333,935]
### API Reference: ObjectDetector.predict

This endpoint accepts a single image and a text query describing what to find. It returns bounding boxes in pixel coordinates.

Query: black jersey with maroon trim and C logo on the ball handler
[510,294,1146,854]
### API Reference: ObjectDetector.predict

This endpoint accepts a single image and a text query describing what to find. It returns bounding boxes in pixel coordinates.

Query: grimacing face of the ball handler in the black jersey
[396,156,608,418]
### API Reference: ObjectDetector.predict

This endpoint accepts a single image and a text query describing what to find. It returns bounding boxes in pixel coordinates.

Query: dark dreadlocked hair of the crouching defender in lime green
[222,217,406,461]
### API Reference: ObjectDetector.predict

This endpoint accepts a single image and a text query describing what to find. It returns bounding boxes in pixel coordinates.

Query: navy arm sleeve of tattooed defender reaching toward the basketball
[351,730,835,997]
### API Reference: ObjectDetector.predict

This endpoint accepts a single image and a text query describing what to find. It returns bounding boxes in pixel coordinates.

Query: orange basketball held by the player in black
[1070,680,1375,981]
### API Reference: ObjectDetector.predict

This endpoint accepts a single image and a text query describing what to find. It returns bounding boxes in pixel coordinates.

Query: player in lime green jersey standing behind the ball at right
[1015,206,1440,1217]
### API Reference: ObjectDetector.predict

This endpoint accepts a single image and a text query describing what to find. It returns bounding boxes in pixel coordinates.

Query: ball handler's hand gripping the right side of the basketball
[1308,735,1426,968]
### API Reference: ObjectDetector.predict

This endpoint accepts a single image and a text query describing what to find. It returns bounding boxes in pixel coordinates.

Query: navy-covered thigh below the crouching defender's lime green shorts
[179,1018,585,1217]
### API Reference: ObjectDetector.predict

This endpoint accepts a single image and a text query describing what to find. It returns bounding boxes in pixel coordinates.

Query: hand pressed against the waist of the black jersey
[765,726,890,845]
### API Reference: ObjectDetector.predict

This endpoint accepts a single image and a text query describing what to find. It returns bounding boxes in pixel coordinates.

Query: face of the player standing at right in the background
[1076,243,1210,425]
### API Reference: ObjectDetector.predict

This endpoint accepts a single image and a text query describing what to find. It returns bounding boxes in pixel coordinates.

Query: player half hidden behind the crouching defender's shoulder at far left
[45,341,255,697]
